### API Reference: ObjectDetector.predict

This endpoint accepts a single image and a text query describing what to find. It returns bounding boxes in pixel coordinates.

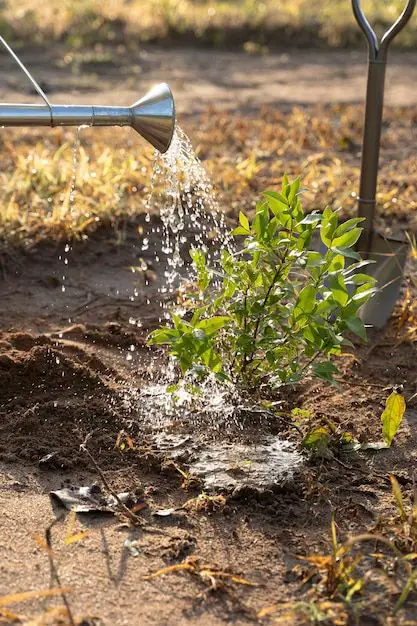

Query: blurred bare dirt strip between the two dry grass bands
[0,44,417,116]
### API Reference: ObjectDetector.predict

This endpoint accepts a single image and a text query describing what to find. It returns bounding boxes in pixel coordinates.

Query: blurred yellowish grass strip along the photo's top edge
[0,0,417,51]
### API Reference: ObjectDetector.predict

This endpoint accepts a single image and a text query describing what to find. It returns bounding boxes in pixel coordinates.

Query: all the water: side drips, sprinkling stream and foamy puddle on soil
[54,127,302,490]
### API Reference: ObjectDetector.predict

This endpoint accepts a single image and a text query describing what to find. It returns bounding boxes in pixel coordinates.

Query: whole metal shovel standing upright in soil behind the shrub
[352,0,416,328]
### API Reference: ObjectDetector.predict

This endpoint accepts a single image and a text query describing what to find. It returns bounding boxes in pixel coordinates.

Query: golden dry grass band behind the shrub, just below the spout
[0,105,417,245]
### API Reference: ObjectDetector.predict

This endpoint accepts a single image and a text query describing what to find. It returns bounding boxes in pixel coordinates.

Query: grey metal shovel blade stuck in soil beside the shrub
[359,231,410,328]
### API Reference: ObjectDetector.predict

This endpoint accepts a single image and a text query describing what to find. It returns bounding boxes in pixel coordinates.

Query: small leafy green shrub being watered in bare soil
[149,177,376,389]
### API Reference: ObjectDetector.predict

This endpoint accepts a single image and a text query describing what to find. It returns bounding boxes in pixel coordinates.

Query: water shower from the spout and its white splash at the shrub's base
[129,126,238,410]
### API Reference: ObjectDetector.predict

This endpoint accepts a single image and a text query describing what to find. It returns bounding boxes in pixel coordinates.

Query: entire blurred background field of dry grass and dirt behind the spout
[0,0,417,250]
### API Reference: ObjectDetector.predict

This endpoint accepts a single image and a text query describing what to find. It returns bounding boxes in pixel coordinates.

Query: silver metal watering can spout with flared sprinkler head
[0,37,175,152]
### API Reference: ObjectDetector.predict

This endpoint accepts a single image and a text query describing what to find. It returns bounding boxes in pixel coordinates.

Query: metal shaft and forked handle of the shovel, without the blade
[352,0,417,250]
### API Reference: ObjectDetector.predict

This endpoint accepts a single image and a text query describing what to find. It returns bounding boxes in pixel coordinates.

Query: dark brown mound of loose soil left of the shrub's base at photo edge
[0,333,135,468]
